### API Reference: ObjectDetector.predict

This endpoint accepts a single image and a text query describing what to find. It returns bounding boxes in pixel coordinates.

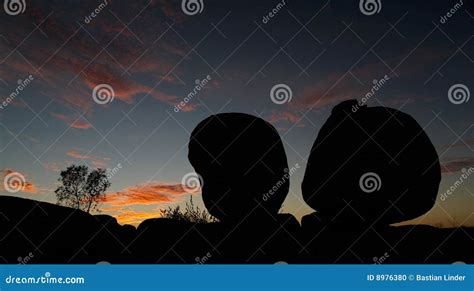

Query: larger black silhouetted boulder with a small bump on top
[302,100,441,225]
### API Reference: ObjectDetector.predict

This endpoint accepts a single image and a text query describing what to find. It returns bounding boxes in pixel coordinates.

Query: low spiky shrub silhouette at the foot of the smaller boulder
[161,197,218,223]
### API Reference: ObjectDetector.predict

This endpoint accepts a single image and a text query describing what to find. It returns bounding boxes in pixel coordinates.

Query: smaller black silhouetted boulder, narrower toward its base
[188,113,289,222]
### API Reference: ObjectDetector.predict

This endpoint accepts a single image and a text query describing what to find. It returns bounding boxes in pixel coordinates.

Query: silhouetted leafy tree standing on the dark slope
[54,165,110,213]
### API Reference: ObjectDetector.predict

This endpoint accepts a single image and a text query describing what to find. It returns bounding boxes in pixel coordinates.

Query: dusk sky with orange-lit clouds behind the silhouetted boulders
[0,0,474,226]
